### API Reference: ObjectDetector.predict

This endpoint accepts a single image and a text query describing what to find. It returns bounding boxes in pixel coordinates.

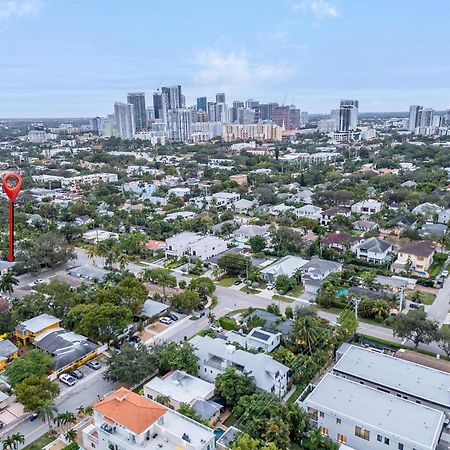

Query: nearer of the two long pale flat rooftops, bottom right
[304,374,444,449]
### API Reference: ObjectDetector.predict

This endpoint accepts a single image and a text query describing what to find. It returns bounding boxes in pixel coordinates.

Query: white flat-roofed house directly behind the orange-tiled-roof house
[144,370,214,410]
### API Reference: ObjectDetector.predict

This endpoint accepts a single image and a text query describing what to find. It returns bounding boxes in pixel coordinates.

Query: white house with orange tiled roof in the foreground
[82,388,215,450]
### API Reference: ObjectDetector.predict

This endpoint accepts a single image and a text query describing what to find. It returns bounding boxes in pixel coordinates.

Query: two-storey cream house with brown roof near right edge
[391,241,436,277]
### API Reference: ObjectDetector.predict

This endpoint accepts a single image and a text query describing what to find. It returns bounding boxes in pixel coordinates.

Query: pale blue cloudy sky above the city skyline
[0,0,450,117]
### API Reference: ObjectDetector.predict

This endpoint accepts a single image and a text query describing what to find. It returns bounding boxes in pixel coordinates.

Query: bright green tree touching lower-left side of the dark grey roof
[5,349,53,387]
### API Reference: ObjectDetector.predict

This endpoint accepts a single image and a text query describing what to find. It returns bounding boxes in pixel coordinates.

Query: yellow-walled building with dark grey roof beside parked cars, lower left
[33,328,99,375]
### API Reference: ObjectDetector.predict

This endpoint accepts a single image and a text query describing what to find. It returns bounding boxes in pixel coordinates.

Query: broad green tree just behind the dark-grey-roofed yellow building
[69,303,132,342]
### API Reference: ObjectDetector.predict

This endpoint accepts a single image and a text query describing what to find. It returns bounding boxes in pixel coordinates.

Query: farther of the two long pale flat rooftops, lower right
[333,345,450,409]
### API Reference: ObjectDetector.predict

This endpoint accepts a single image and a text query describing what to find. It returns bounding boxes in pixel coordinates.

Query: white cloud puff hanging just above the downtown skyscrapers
[195,50,293,87]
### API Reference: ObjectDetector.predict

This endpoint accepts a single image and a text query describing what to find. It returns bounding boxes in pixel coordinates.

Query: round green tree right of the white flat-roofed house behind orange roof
[215,366,255,407]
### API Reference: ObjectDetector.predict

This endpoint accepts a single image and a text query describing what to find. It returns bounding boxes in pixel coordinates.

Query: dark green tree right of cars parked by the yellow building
[104,344,157,385]
